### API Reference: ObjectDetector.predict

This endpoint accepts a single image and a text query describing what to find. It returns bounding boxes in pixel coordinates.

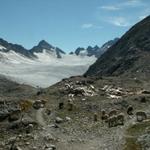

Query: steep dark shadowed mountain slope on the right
[85,16,150,76]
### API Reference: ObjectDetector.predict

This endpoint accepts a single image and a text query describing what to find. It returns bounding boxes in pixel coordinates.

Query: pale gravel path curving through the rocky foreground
[36,108,138,150]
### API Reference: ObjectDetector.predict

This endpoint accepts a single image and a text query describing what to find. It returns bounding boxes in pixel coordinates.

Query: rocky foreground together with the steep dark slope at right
[0,17,150,150]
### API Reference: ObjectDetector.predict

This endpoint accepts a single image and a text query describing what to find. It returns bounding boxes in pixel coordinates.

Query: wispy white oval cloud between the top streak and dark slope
[107,17,130,27]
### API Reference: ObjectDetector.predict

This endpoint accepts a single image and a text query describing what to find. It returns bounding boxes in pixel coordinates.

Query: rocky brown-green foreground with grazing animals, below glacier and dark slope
[0,77,150,150]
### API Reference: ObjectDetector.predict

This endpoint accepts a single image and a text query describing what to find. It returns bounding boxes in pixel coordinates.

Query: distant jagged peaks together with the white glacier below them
[0,36,116,87]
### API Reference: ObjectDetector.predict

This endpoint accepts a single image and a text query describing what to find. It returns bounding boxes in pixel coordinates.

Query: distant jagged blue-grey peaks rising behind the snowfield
[0,38,118,59]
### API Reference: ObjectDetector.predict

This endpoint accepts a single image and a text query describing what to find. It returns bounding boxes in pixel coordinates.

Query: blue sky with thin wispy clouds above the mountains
[0,0,150,52]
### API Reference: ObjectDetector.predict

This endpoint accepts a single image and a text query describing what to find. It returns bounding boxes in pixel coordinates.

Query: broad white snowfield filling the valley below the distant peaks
[0,50,96,87]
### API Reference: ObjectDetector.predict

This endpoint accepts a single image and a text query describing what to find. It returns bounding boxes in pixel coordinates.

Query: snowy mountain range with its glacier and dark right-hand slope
[0,16,150,87]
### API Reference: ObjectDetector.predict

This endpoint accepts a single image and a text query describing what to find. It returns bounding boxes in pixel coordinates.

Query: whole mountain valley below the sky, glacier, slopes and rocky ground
[0,13,150,150]
